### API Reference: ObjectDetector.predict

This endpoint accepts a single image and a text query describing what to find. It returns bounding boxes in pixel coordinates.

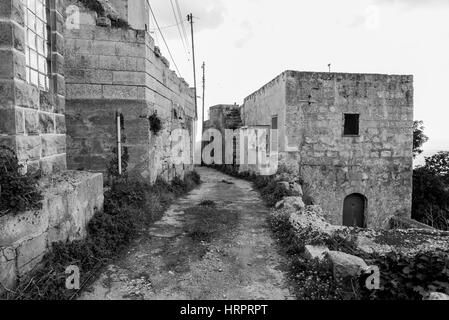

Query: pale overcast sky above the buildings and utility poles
[150,0,449,150]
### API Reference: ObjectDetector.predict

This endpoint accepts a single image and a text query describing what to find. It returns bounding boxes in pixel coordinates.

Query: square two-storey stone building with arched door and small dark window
[211,71,413,227]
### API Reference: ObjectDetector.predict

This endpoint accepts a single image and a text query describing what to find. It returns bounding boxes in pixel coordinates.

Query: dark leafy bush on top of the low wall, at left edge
[0,146,43,216]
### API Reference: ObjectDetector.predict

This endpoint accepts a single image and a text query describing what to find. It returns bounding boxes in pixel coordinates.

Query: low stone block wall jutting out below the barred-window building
[0,171,104,293]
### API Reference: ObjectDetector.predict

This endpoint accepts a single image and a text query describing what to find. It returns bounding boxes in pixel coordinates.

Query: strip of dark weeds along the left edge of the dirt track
[0,172,200,300]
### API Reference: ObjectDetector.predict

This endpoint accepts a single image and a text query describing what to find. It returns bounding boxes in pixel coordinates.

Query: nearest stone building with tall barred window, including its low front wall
[0,0,103,294]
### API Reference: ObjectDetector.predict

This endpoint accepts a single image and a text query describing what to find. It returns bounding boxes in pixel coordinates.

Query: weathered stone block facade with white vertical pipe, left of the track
[64,0,195,181]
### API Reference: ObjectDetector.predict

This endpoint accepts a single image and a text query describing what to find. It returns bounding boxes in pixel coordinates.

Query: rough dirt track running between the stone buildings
[81,168,293,300]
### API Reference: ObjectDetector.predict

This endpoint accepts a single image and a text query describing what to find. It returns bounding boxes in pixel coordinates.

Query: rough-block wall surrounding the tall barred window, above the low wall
[0,0,66,174]
